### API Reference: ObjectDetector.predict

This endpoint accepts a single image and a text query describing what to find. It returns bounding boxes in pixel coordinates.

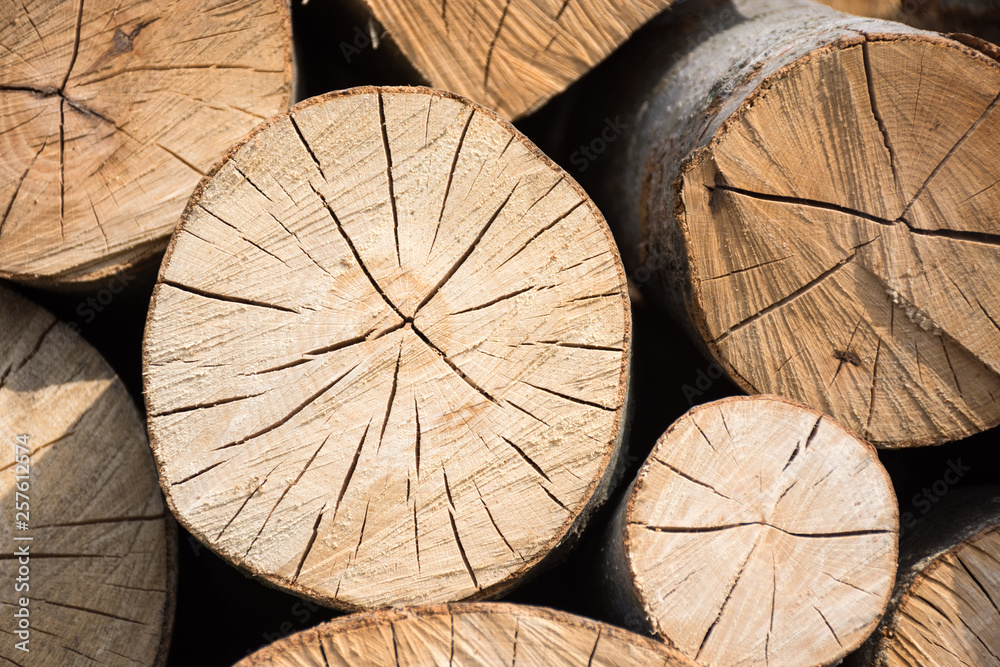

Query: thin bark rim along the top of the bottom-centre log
[236,602,695,667]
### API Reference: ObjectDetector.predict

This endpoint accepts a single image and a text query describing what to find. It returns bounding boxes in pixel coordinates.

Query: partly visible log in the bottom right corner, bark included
[850,487,1000,667]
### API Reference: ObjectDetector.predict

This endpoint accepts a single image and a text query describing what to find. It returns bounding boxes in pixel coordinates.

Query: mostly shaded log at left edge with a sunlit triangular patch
[0,287,177,667]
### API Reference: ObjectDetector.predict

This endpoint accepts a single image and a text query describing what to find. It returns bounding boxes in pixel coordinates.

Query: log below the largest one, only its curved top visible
[238,603,695,667]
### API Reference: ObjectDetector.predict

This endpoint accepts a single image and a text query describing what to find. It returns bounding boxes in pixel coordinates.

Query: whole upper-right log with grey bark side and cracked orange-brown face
[587,0,1000,447]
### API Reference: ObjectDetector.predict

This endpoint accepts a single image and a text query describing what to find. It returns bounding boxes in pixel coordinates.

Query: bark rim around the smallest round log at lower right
[602,394,899,665]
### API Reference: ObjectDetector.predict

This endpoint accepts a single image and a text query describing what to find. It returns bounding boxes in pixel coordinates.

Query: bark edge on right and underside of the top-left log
[0,0,302,292]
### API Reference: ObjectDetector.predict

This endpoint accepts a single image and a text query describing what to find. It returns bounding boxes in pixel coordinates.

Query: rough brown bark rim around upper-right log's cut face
[667,30,1000,449]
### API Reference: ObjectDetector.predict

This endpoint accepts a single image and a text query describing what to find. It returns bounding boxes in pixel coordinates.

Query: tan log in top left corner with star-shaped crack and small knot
[0,0,292,286]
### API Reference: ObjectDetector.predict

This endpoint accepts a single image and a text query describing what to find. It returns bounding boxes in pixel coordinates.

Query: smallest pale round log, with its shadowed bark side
[601,396,899,667]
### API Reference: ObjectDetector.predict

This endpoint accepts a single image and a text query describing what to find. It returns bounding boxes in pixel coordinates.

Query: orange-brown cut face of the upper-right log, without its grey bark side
[676,32,1000,447]
